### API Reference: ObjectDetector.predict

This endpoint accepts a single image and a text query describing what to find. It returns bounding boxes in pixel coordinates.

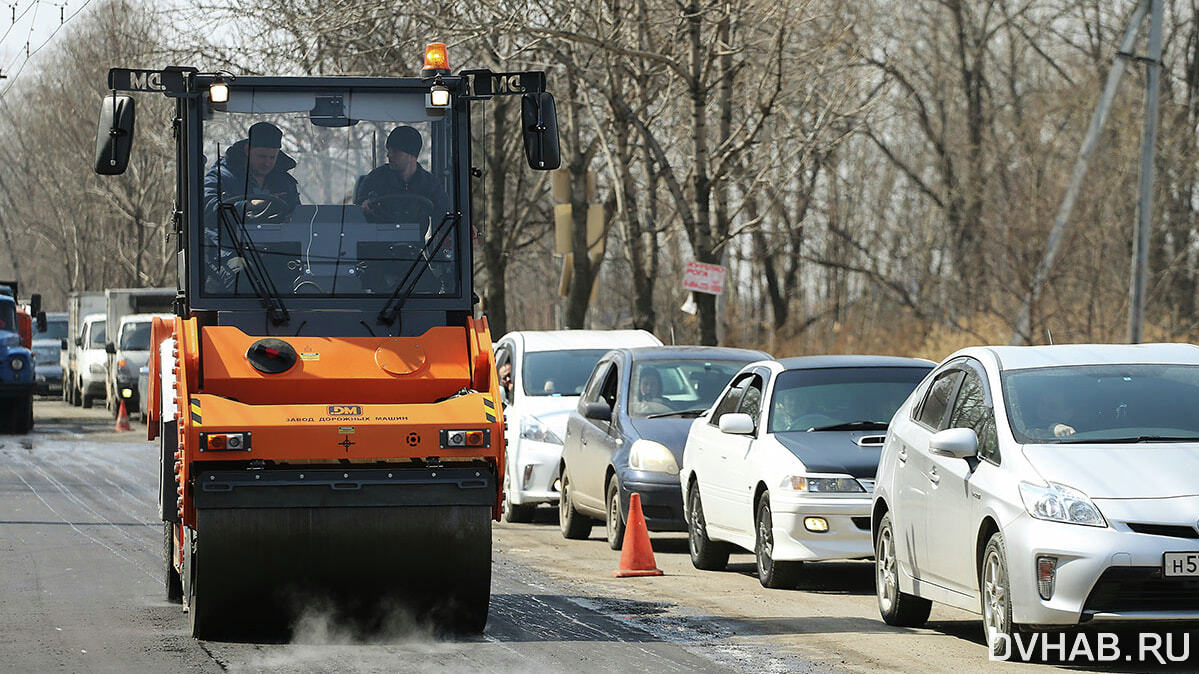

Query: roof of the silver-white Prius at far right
[978,344,1199,369]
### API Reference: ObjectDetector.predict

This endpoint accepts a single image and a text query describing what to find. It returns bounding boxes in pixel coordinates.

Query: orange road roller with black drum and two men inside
[95,46,559,637]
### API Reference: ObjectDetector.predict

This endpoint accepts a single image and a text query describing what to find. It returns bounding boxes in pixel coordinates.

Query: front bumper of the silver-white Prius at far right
[1004,497,1199,626]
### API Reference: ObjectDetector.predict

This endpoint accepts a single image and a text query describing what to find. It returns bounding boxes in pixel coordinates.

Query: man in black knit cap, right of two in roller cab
[354,126,451,226]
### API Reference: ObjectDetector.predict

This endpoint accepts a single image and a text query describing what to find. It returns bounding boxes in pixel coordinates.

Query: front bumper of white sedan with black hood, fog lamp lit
[770,492,874,561]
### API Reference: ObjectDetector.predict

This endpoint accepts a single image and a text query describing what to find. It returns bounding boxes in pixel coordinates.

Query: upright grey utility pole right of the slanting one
[1128,0,1162,344]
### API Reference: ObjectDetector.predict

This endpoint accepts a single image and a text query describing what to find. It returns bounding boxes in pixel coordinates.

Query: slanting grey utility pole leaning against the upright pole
[1010,0,1162,344]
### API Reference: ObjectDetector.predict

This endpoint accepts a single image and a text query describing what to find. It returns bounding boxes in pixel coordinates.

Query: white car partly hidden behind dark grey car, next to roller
[495,330,662,522]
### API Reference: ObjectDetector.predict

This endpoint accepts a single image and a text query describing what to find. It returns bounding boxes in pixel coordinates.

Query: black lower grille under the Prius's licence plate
[1083,566,1199,613]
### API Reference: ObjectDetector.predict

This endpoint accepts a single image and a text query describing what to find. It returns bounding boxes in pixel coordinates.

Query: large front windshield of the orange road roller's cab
[200,86,464,297]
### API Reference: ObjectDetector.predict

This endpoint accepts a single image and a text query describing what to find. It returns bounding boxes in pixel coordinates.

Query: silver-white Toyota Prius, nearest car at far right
[872,344,1199,652]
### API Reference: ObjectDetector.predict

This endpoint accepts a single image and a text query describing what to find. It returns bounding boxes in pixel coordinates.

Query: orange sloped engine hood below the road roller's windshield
[199,326,471,405]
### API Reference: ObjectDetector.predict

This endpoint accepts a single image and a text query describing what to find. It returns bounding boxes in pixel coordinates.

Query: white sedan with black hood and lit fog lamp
[680,356,933,588]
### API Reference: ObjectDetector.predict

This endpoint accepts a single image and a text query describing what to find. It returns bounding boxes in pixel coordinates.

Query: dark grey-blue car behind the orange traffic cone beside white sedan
[559,347,770,549]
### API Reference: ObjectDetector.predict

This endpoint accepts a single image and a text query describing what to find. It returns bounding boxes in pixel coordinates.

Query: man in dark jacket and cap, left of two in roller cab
[204,121,300,222]
